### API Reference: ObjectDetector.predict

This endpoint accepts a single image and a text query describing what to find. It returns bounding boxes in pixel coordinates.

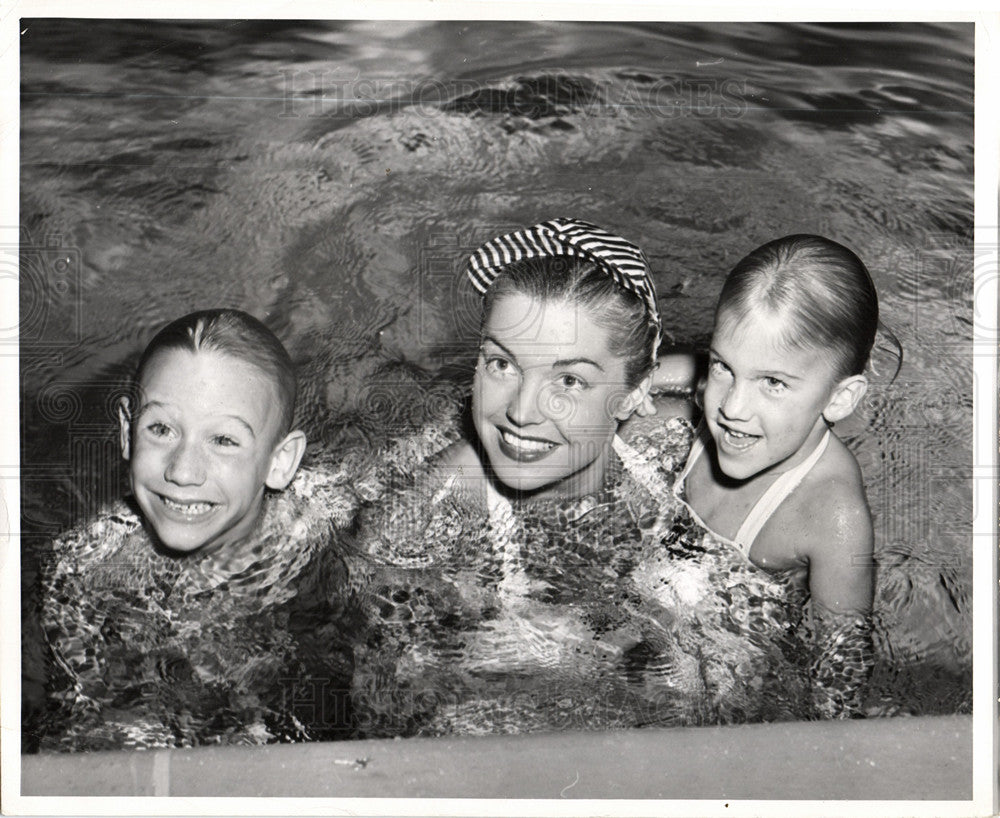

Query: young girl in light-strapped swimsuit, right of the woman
[676,235,878,715]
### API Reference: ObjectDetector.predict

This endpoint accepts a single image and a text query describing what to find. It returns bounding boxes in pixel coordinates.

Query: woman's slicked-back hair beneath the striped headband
[481,256,658,389]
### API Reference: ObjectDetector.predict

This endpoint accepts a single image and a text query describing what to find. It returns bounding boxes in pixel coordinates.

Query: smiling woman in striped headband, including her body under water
[352,219,812,735]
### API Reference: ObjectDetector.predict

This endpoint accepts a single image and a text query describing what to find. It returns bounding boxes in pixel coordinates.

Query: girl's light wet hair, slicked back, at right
[715,234,884,378]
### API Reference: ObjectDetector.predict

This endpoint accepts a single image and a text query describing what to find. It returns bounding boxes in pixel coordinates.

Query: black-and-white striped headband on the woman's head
[466,219,660,342]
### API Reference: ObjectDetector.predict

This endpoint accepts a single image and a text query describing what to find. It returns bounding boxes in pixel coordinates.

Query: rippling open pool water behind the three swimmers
[20,20,974,732]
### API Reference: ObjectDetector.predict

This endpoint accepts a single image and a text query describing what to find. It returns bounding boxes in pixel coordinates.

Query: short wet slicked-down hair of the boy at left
[135,309,298,438]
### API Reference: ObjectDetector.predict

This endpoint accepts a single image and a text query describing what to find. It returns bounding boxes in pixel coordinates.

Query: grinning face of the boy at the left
[122,349,298,551]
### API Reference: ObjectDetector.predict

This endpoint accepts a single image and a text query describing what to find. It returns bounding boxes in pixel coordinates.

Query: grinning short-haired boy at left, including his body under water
[42,310,354,750]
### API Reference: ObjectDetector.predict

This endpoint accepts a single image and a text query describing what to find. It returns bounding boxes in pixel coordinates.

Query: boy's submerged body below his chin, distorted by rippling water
[41,469,366,750]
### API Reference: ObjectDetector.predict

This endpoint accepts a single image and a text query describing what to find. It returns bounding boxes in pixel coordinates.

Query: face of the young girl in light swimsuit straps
[704,312,842,480]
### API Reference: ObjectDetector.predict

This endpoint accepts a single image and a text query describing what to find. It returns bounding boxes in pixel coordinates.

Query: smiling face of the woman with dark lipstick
[472,293,646,497]
